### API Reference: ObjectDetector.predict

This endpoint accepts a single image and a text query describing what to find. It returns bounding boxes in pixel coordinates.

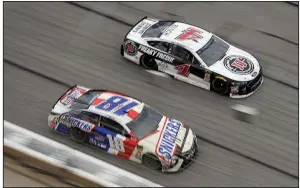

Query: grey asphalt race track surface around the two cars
[4,2,299,187]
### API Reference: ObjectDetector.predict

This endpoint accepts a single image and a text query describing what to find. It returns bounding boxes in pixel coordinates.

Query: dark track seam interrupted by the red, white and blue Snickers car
[3,58,298,179]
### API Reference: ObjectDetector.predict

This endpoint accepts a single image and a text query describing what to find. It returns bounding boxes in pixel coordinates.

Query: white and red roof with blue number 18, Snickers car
[88,91,144,124]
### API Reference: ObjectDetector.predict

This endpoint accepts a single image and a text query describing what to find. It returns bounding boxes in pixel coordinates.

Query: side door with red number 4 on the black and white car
[170,44,210,89]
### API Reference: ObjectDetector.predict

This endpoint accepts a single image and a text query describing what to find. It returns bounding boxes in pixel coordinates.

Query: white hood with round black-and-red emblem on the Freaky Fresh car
[208,46,260,81]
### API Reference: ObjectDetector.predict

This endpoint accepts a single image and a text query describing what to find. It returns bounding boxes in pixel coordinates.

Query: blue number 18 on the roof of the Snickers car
[96,96,138,115]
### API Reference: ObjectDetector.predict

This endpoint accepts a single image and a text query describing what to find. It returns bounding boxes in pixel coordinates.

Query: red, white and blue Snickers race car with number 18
[48,85,197,172]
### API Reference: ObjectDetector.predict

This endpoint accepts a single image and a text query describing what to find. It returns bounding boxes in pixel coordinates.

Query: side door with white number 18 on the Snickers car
[91,116,137,158]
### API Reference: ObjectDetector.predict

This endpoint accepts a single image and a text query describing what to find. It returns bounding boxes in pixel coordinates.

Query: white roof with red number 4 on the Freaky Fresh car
[160,22,212,52]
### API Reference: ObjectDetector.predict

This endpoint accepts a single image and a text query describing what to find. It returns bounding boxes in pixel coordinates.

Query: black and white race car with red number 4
[121,17,263,98]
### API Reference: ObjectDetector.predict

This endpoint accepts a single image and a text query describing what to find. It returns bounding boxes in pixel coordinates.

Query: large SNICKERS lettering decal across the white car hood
[157,119,182,159]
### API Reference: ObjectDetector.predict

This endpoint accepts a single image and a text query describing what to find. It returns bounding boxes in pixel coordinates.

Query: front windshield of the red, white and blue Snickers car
[127,105,163,139]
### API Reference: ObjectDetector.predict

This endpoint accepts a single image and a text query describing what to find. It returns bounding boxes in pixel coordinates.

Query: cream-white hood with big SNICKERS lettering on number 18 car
[142,116,194,159]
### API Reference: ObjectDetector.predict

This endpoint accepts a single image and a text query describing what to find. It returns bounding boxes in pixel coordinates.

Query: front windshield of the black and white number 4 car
[197,35,229,67]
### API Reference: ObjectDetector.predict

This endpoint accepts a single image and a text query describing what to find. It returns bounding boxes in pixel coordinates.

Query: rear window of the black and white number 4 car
[142,21,174,38]
